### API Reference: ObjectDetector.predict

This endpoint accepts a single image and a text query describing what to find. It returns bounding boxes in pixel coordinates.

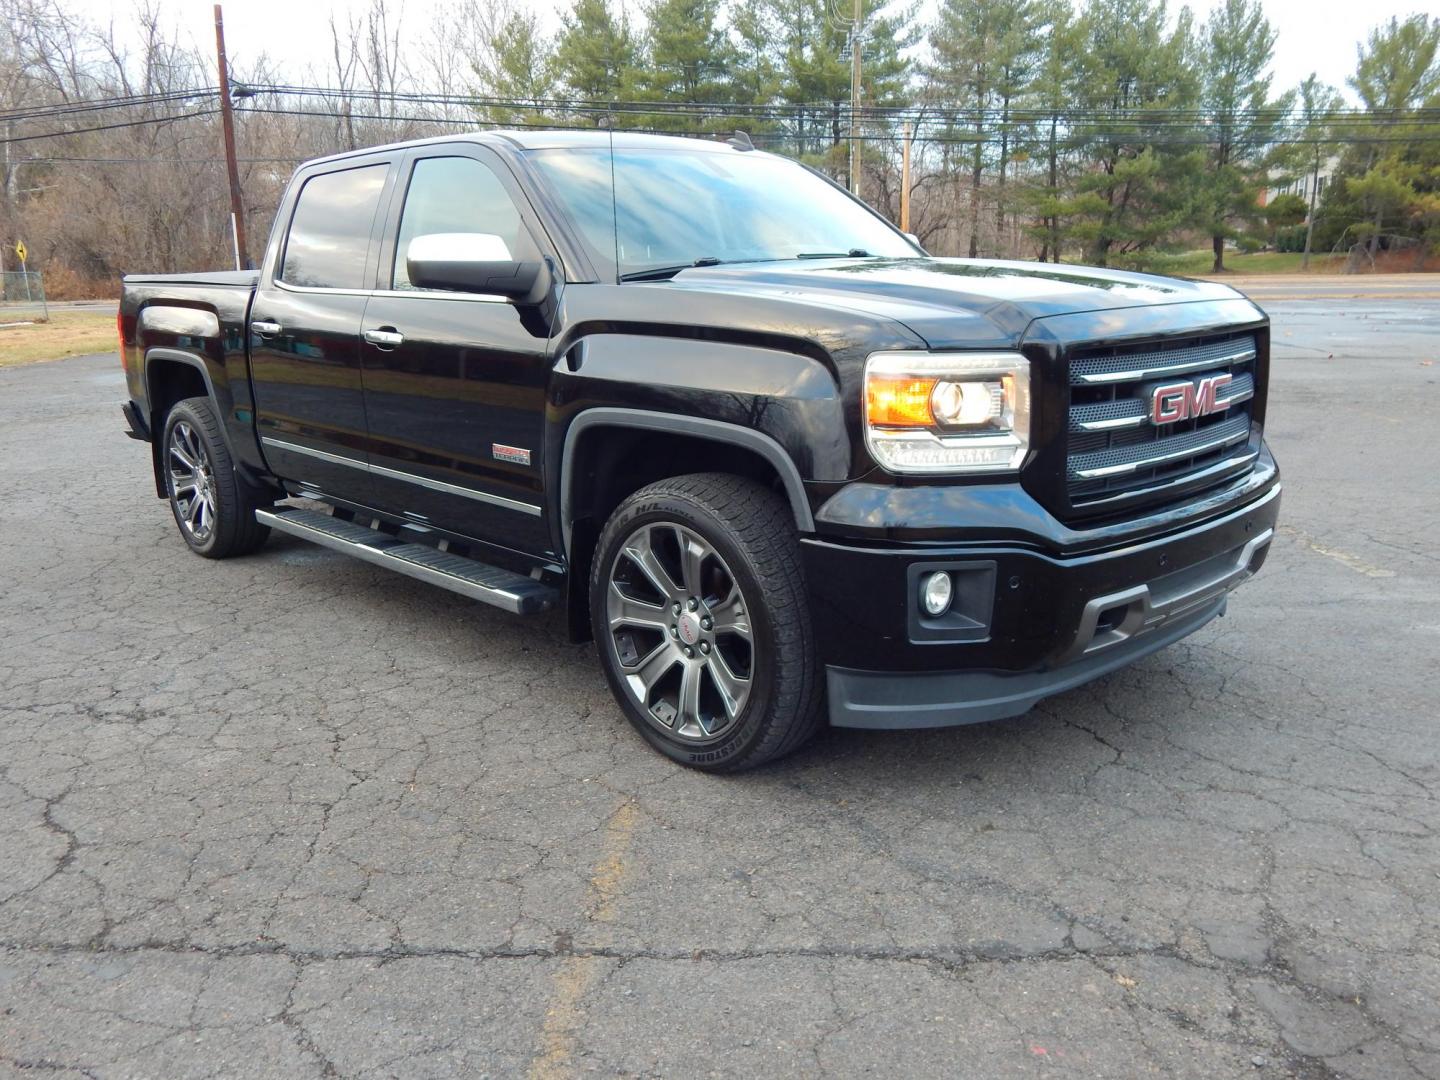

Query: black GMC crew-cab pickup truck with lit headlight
[120,132,1280,770]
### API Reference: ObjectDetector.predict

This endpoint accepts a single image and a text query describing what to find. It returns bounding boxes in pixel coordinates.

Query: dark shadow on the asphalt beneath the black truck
[259,536,1233,788]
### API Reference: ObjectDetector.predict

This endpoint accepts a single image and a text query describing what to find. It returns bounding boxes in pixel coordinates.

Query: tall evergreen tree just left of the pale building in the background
[1200,0,1295,274]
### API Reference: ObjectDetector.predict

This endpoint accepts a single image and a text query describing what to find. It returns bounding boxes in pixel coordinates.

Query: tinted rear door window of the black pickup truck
[279,164,390,289]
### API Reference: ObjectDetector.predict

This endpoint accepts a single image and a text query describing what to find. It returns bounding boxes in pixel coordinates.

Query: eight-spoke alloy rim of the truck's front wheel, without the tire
[606,521,755,743]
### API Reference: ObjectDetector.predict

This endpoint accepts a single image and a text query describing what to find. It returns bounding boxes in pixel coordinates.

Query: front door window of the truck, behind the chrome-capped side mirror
[392,157,524,289]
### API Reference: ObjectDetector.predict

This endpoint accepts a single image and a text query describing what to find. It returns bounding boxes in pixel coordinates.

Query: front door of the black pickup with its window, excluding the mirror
[360,147,552,554]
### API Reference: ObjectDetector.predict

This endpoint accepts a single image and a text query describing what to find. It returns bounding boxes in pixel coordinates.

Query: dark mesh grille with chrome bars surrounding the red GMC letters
[1066,334,1257,508]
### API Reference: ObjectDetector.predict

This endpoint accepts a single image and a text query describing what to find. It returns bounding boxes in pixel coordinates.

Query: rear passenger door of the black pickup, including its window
[251,160,390,503]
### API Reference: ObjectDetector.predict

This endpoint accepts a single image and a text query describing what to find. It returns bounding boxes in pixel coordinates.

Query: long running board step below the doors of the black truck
[255,507,557,615]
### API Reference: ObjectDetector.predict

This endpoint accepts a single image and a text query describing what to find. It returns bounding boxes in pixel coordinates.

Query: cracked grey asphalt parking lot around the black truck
[0,298,1440,1080]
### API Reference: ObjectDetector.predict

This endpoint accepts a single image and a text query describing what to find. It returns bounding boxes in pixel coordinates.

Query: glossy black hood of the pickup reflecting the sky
[670,258,1240,348]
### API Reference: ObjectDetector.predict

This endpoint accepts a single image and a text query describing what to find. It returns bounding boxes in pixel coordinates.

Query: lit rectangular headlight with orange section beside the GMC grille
[865,353,1030,472]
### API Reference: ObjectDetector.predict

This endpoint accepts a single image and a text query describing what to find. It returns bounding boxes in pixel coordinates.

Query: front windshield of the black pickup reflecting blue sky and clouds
[531,147,919,276]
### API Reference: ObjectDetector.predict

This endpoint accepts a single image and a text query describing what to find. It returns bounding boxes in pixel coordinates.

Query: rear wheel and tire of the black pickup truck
[160,397,271,559]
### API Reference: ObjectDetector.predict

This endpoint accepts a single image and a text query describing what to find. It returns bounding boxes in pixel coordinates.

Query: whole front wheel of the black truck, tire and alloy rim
[590,472,822,772]
